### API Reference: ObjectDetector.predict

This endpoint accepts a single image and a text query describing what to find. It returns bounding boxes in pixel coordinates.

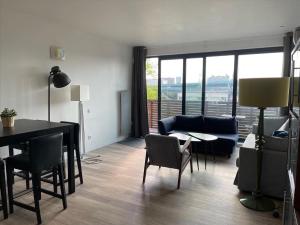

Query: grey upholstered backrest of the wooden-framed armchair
[145,134,182,169]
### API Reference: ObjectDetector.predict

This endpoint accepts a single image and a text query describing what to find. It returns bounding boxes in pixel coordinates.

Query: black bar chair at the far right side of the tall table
[42,121,83,192]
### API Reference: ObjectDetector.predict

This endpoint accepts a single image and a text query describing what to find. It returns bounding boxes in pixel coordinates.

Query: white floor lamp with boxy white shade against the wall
[71,85,90,155]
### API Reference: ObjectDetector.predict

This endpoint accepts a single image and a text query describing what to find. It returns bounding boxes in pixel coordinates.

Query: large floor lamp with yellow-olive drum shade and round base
[239,77,289,211]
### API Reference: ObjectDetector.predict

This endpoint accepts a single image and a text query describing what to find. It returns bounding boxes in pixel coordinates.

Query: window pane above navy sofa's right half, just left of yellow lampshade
[205,55,234,117]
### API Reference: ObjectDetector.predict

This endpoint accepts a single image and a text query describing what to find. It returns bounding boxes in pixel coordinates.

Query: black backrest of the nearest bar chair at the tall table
[29,133,63,173]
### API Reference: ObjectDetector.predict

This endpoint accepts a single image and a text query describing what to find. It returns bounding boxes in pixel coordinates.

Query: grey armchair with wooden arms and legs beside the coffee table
[143,134,193,189]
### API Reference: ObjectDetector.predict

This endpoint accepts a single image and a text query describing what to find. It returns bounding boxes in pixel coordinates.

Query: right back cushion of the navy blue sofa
[203,117,237,134]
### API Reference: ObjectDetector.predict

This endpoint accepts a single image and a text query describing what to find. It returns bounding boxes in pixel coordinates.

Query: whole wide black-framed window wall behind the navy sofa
[146,47,283,138]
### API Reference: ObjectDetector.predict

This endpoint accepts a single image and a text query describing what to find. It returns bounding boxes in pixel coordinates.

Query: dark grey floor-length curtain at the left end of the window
[131,46,149,138]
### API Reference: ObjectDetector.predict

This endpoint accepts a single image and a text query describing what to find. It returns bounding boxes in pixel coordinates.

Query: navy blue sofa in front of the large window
[158,115,239,157]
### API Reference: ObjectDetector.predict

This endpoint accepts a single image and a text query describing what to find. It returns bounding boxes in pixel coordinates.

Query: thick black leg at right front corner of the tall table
[68,126,75,194]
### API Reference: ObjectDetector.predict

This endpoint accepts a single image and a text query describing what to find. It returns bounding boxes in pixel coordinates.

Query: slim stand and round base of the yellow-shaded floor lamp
[240,107,275,211]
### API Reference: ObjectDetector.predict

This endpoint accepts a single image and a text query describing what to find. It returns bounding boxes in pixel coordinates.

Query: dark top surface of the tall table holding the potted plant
[0,119,72,138]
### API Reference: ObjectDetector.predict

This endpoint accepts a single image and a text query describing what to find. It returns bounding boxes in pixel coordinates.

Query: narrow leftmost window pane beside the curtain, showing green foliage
[146,58,158,129]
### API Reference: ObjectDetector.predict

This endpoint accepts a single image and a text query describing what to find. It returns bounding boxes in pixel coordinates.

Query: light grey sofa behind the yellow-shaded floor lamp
[234,117,288,198]
